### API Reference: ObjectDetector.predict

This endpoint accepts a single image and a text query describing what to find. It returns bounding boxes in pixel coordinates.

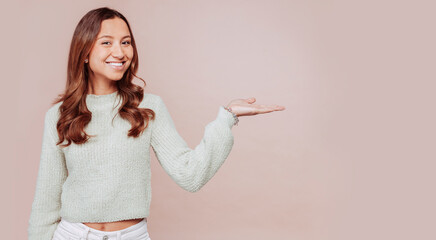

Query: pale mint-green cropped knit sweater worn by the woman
[28,92,235,240]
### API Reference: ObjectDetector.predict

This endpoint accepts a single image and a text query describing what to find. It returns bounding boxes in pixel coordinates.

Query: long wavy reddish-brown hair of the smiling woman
[53,7,155,147]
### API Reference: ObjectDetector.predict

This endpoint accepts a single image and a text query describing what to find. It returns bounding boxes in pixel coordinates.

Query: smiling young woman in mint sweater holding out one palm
[28,8,284,240]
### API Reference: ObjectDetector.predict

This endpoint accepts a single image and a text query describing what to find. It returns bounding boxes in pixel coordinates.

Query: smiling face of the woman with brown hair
[85,18,133,85]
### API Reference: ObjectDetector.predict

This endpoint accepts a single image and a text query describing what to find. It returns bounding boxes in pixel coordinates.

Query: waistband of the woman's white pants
[59,218,147,239]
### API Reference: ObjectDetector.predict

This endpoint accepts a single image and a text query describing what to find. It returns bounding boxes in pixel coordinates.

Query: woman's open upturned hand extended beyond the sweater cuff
[227,97,285,117]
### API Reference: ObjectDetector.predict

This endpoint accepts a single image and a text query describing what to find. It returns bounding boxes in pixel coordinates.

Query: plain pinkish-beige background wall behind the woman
[0,0,436,240]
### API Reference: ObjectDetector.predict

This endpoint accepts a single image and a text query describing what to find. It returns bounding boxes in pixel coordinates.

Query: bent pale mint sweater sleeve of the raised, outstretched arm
[151,96,235,192]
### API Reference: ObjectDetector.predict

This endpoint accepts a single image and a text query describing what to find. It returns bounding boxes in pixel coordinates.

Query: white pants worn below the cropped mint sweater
[52,218,151,240]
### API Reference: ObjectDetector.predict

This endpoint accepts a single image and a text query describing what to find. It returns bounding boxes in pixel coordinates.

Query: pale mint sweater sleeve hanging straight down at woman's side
[28,108,68,240]
